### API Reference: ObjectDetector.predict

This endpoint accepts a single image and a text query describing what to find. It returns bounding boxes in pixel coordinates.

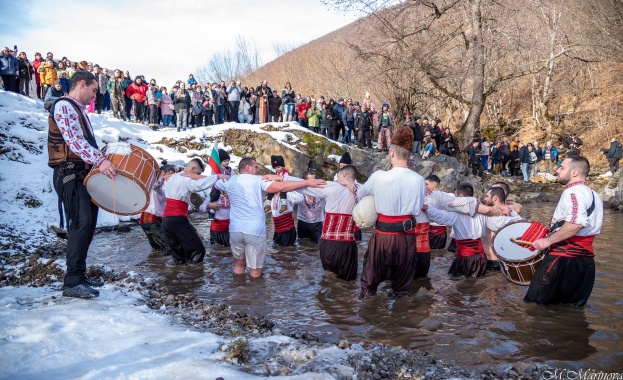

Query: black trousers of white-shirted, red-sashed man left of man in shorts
[162,216,206,263]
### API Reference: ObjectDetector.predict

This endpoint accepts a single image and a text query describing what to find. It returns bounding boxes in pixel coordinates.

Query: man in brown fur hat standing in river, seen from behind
[357,126,426,298]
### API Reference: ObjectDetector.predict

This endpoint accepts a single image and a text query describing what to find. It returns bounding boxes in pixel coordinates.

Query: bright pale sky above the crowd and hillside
[0,0,356,86]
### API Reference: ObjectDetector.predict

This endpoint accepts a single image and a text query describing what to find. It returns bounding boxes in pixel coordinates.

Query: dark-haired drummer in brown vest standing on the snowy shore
[48,71,116,298]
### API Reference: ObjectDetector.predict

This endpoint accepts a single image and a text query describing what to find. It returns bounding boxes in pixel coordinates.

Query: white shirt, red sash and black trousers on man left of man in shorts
[162,168,217,264]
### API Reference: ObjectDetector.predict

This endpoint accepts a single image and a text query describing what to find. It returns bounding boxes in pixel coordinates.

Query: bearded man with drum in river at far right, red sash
[524,155,603,306]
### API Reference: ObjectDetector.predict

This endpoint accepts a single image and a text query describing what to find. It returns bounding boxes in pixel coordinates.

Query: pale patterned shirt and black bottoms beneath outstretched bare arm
[288,191,325,244]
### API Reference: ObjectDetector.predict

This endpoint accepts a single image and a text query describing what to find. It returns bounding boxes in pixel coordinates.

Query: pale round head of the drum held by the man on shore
[86,172,149,215]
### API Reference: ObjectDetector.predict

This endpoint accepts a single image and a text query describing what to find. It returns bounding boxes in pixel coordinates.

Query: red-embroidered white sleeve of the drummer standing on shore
[54,101,105,166]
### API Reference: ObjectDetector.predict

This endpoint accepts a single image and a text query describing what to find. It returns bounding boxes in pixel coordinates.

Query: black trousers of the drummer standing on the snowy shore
[54,166,98,287]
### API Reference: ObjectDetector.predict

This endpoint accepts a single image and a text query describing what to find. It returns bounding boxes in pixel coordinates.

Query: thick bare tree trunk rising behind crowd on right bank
[461,0,485,148]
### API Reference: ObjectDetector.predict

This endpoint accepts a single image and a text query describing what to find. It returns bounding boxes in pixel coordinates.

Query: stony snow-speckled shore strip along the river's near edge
[0,239,551,379]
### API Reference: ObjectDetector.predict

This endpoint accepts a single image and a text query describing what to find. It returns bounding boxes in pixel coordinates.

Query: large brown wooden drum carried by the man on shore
[84,143,159,215]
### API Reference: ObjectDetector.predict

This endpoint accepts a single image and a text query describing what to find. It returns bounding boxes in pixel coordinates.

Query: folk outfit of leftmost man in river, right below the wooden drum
[139,174,171,255]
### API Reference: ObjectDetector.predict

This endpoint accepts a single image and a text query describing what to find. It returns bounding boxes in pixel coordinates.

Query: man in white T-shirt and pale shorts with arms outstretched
[214,157,326,277]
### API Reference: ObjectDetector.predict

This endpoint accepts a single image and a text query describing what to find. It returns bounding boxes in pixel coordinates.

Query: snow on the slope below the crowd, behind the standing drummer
[0,90,307,253]
